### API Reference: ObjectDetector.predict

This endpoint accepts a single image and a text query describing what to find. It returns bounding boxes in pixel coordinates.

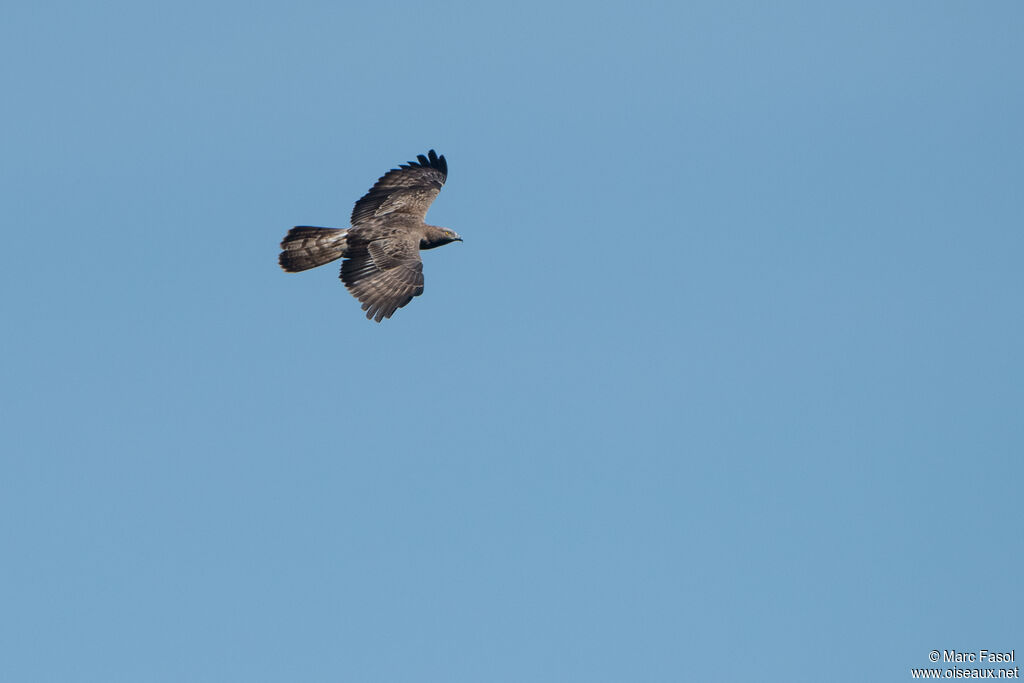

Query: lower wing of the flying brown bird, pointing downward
[341,232,423,323]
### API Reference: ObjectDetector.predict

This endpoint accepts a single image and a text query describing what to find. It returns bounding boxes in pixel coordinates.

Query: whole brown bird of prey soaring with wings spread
[278,150,462,323]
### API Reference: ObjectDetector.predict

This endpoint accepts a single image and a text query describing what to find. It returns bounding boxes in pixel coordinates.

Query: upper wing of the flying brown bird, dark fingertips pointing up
[352,150,447,227]
